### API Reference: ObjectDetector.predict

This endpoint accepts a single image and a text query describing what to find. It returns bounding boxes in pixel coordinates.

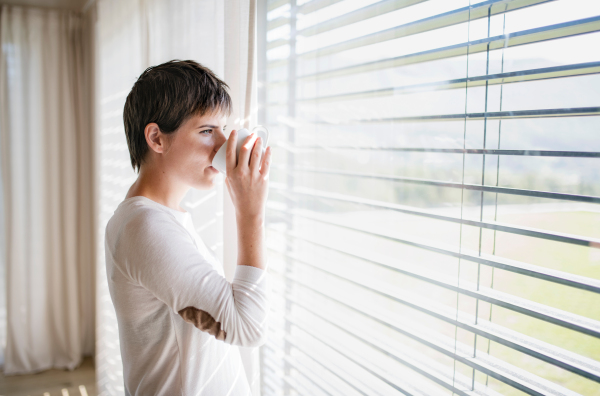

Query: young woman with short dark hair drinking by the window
[105,61,271,396]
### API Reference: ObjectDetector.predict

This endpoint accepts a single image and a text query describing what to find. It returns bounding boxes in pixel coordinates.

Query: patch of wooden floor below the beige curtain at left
[0,357,98,396]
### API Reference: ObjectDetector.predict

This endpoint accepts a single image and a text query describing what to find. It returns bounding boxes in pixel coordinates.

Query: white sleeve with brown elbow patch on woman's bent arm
[125,211,270,347]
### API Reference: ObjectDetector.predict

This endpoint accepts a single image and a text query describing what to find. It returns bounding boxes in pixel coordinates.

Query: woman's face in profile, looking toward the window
[163,113,227,190]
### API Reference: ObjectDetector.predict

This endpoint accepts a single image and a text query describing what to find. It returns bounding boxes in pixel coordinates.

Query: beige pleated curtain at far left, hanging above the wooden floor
[0,6,95,374]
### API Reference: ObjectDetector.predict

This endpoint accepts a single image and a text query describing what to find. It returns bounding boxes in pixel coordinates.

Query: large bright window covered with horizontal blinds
[258,0,600,396]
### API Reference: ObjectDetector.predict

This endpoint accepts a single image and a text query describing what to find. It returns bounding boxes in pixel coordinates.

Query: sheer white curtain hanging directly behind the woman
[93,0,260,396]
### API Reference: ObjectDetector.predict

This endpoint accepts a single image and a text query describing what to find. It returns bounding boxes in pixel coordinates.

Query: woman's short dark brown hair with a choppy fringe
[123,59,232,173]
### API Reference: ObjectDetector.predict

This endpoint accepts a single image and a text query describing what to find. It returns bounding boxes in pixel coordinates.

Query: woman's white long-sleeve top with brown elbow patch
[105,196,270,396]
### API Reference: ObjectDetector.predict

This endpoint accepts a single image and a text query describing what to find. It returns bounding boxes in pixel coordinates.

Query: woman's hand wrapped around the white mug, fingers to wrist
[225,130,271,221]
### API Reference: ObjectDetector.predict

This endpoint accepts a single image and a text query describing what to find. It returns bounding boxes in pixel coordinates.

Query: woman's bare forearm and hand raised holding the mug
[225,130,271,270]
